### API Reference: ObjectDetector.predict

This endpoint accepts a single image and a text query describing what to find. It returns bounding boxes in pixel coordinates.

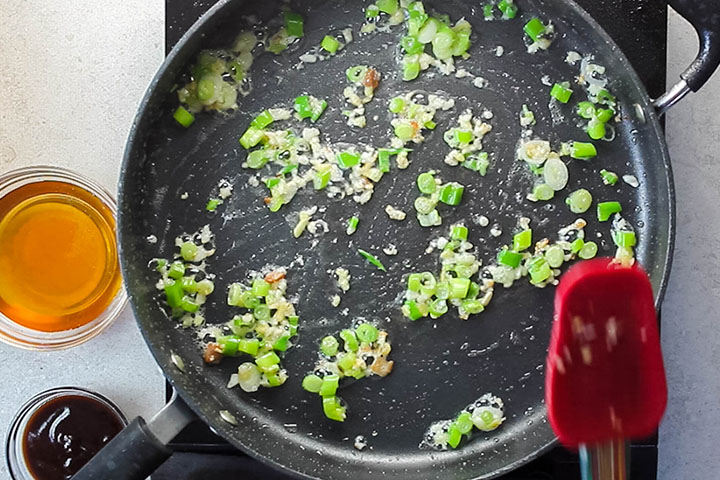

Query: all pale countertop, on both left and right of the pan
[0,0,720,480]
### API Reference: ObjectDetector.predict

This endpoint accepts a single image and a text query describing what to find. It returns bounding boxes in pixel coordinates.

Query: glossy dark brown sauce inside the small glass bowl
[23,395,123,480]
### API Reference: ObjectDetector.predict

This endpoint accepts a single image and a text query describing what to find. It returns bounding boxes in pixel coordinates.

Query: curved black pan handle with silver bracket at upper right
[654,0,720,115]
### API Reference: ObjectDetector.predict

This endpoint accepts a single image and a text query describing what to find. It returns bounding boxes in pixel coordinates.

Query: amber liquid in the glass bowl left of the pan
[0,181,121,332]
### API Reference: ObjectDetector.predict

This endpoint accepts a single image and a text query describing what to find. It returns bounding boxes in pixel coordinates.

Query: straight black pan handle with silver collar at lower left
[72,393,195,480]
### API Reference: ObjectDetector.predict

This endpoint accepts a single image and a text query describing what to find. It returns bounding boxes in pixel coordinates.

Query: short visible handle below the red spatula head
[580,439,629,480]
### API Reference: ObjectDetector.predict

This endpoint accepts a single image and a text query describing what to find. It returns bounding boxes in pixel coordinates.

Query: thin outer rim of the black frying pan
[117,0,676,480]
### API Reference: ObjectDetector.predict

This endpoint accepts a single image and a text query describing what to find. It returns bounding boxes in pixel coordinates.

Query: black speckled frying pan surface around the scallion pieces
[120,0,673,479]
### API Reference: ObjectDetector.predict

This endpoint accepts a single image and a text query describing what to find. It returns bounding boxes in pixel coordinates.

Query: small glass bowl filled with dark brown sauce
[6,387,127,480]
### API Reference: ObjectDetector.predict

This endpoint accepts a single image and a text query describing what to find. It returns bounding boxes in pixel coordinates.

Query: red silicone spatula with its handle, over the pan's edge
[545,258,667,480]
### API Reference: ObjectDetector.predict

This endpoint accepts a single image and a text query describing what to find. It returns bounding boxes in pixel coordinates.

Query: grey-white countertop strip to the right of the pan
[658,10,720,480]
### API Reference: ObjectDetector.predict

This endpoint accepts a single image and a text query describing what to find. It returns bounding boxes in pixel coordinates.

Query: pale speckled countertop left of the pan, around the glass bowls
[0,0,165,478]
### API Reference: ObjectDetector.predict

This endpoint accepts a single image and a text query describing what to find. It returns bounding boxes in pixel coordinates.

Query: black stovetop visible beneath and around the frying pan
[152,0,667,480]
